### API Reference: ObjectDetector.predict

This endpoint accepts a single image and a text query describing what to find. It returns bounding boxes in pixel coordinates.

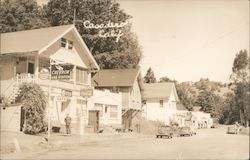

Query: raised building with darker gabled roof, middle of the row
[92,68,143,129]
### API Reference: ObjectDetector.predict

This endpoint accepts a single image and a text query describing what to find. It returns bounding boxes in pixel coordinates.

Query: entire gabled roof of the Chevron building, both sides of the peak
[0,25,99,69]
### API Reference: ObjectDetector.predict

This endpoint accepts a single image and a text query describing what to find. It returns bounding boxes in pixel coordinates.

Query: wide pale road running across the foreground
[0,127,249,160]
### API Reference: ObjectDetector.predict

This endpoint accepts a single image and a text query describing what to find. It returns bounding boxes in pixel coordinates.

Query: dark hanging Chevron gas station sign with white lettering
[51,64,73,80]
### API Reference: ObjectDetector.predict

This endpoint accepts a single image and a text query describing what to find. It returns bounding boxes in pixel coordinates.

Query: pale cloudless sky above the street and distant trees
[117,0,249,82]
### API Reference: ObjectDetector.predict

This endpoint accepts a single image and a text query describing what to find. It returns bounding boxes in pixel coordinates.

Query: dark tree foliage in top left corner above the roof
[0,0,49,33]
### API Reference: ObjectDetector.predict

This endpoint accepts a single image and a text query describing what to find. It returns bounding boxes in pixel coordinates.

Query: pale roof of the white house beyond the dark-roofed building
[143,83,179,101]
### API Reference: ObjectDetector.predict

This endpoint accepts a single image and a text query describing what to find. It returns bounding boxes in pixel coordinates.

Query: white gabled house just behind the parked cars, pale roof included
[143,83,179,125]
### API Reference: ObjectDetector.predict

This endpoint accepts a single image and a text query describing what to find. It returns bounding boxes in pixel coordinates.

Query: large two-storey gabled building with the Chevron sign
[0,25,99,133]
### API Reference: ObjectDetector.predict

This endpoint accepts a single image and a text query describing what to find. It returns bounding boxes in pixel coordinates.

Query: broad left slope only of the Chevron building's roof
[1,25,74,54]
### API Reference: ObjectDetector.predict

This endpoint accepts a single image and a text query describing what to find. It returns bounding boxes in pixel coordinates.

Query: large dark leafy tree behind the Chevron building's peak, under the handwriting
[44,0,142,69]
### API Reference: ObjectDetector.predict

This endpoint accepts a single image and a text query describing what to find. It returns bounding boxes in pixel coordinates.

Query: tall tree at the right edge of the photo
[231,50,250,126]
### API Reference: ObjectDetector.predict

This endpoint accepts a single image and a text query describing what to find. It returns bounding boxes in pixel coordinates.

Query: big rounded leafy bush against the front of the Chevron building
[17,83,46,134]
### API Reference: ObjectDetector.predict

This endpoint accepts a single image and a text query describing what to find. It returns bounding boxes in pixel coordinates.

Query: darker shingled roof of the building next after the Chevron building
[92,68,143,87]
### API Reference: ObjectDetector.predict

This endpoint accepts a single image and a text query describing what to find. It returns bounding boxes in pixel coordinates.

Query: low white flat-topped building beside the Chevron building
[87,89,122,132]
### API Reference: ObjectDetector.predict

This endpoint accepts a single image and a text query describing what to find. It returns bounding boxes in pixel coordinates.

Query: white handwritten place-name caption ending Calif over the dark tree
[83,20,128,42]
